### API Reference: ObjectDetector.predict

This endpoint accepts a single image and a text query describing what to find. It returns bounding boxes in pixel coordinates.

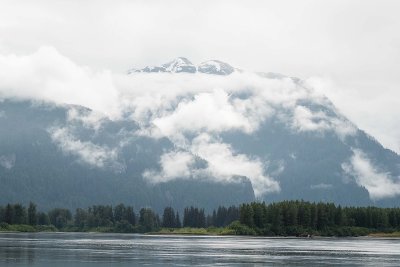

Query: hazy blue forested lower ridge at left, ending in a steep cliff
[0,101,254,210]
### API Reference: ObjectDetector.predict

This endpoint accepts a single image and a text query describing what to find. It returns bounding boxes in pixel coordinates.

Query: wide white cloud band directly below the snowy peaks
[114,73,288,128]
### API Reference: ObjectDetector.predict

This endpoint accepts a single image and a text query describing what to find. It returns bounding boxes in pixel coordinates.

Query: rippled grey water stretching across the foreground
[0,233,400,267]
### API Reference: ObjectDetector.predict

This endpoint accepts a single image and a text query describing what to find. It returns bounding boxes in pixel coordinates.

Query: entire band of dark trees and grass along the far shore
[0,201,400,238]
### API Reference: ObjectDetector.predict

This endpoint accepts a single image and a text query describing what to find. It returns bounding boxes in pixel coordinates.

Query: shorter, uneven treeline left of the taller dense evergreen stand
[0,202,239,233]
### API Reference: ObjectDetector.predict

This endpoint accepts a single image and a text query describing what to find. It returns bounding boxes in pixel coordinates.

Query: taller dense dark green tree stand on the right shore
[236,201,400,236]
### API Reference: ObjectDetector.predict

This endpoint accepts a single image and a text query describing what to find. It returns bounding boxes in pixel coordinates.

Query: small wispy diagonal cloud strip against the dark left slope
[49,128,120,168]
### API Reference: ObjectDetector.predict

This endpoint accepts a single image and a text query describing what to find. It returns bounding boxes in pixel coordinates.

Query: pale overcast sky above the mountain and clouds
[0,0,400,153]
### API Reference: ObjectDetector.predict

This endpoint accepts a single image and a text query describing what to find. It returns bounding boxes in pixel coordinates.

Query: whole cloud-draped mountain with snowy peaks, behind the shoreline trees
[0,58,400,211]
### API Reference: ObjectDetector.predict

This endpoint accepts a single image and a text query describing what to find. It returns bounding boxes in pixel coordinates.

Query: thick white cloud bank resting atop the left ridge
[0,47,119,117]
